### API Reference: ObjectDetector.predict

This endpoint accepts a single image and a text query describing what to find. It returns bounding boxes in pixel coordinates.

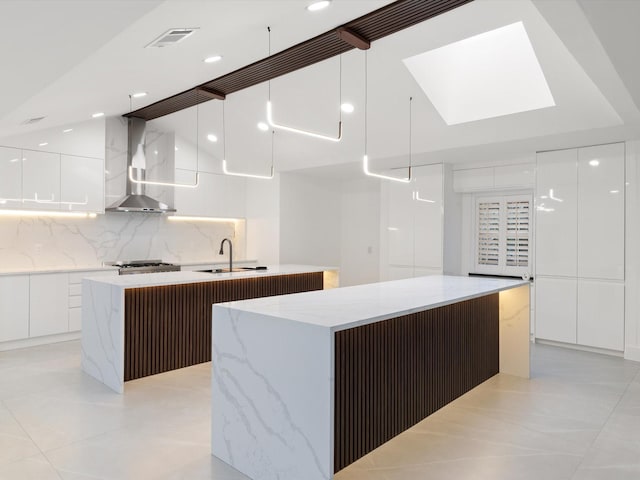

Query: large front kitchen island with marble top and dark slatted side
[211,276,529,480]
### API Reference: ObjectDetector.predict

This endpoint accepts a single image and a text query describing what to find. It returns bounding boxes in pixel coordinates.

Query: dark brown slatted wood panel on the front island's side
[334,293,499,472]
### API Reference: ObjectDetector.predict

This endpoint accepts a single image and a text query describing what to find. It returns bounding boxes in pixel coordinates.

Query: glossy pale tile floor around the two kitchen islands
[0,342,640,480]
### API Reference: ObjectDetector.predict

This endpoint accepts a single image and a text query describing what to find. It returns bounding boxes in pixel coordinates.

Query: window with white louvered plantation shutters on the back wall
[475,195,532,276]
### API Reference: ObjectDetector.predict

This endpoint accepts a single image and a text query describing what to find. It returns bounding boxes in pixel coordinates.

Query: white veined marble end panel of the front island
[212,306,332,480]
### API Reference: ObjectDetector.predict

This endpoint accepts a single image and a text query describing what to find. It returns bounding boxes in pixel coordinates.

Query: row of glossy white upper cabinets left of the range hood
[0,147,104,212]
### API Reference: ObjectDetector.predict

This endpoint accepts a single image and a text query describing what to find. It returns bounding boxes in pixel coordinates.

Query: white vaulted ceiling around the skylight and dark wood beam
[0,0,640,178]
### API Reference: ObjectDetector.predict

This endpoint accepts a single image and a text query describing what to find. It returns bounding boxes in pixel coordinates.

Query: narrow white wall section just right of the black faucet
[246,174,280,265]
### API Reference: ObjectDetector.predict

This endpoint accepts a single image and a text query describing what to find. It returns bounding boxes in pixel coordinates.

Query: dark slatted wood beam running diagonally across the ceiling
[124,0,473,120]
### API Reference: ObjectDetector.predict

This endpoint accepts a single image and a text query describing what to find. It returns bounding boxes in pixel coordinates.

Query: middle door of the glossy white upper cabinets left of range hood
[22,150,60,210]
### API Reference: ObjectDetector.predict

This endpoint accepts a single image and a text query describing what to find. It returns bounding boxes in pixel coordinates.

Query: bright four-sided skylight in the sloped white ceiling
[403,22,555,125]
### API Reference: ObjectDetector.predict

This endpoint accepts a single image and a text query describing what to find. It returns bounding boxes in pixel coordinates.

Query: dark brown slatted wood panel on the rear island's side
[124,272,323,381]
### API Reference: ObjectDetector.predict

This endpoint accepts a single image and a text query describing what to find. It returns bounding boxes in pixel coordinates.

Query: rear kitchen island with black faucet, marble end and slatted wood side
[82,265,337,393]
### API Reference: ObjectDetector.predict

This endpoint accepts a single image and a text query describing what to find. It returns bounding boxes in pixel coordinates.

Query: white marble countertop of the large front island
[214,275,529,331]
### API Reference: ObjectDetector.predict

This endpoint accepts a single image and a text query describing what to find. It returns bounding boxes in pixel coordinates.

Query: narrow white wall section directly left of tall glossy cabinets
[340,178,380,287]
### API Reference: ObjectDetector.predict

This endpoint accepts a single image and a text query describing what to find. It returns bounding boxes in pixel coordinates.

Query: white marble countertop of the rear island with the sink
[84,265,337,288]
